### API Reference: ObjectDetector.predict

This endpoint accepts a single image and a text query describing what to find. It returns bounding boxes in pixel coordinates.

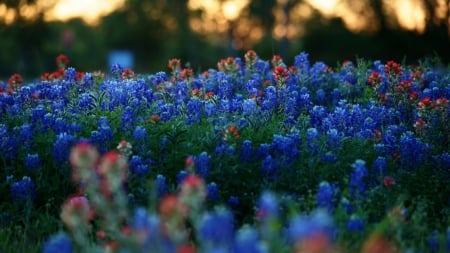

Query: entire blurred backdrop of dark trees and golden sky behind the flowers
[0,0,450,78]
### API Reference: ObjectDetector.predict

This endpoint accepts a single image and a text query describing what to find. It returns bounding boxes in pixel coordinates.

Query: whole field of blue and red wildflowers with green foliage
[0,50,450,253]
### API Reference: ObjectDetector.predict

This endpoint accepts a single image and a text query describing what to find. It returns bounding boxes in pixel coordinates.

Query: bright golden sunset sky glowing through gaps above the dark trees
[0,0,450,44]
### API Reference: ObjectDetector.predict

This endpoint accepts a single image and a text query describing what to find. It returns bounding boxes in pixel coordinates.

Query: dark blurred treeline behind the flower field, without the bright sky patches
[0,0,450,78]
